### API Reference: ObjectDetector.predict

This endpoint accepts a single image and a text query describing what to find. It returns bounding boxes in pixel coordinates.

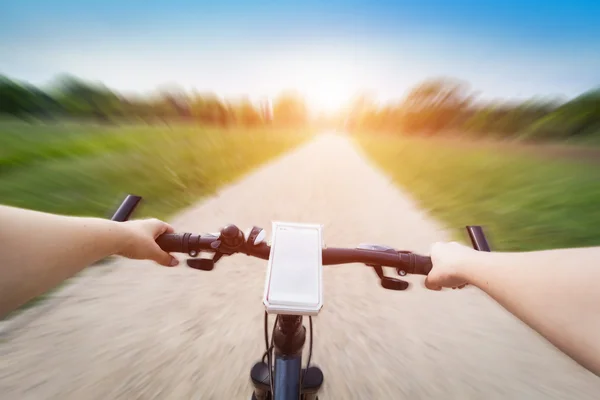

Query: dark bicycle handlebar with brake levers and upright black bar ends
[112,195,490,290]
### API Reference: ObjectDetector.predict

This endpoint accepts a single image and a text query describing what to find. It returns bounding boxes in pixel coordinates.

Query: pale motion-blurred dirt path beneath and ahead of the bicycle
[0,136,600,400]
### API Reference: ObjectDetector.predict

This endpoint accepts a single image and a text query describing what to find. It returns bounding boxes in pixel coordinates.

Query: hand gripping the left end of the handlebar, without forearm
[117,218,179,267]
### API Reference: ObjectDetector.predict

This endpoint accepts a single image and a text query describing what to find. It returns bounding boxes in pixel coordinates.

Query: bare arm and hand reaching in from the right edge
[427,243,600,375]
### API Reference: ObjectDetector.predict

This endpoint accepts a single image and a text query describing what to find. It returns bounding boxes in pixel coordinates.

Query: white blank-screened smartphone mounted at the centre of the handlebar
[263,222,323,315]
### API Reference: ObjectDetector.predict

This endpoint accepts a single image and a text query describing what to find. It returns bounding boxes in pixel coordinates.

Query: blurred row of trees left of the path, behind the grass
[0,75,308,126]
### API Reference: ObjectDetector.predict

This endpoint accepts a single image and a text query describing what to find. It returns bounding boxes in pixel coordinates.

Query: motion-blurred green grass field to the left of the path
[0,123,309,218]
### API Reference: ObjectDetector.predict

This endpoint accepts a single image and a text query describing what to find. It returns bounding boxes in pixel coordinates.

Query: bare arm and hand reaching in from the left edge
[0,206,176,317]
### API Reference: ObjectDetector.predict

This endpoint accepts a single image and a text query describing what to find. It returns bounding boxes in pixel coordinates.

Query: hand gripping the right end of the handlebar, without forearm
[425,242,476,290]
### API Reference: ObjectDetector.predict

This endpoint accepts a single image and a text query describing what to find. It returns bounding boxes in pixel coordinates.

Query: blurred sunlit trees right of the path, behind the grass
[346,78,600,140]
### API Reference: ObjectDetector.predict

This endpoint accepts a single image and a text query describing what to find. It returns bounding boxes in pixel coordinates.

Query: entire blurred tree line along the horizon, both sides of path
[0,75,600,140]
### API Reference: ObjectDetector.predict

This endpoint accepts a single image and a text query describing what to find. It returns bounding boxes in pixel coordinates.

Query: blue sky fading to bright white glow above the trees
[0,0,600,110]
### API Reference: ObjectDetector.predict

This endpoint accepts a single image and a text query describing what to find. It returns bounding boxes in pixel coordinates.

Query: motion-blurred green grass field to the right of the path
[357,135,600,251]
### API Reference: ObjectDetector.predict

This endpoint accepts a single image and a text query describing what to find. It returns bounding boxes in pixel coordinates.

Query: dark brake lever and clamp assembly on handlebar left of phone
[187,225,265,271]
